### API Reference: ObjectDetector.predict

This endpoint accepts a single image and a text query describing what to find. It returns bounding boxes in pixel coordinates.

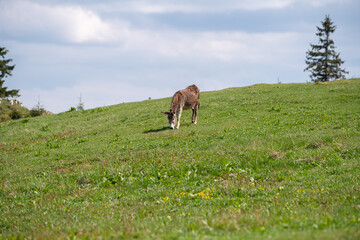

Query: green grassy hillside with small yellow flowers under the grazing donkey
[0,79,360,239]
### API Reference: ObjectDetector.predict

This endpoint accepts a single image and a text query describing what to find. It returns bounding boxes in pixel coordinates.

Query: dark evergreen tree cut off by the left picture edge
[0,47,20,99]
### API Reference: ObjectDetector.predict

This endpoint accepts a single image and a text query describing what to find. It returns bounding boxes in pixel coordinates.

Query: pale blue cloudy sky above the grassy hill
[0,0,360,113]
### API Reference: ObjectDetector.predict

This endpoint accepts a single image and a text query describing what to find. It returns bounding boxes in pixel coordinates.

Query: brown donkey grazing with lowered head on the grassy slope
[162,85,200,129]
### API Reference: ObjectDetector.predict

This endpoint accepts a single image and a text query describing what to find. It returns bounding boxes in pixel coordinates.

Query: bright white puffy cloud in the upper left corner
[0,0,113,43]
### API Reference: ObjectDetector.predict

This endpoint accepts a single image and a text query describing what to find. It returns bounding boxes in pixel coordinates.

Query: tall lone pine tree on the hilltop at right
[304,15,349,83]
